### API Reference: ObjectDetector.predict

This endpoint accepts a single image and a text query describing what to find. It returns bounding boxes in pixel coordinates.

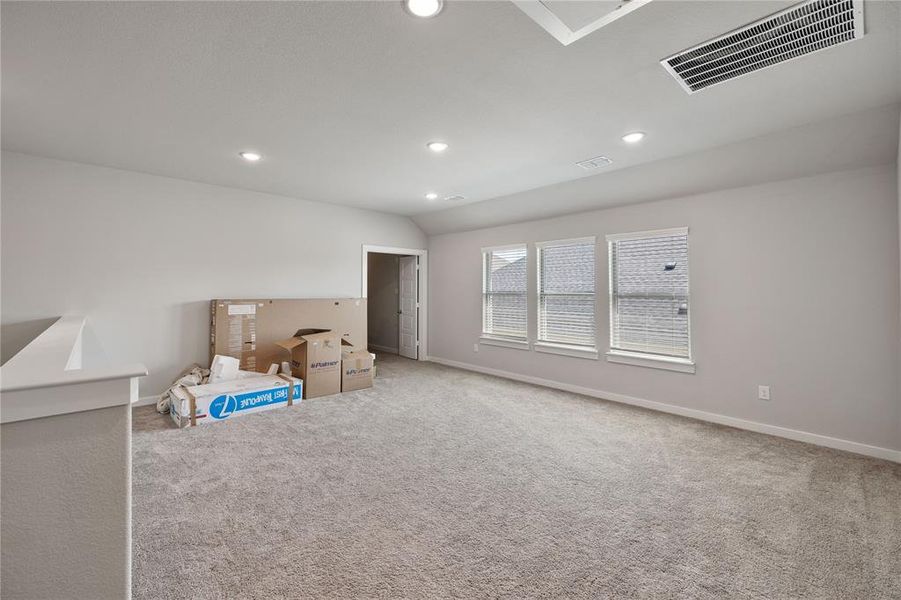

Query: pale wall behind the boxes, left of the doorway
[0,152,426,395]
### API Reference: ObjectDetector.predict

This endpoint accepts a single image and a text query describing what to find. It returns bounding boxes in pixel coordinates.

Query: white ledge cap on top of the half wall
[0,316,147,423]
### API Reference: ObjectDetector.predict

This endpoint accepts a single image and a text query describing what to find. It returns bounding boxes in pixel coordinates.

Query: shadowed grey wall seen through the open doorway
[366,252,400,352]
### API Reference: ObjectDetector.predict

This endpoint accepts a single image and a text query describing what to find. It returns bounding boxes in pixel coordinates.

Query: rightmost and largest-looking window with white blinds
[607,228,691,359]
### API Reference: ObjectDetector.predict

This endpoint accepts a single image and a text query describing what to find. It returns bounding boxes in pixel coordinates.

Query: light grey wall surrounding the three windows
[429,164,901,449]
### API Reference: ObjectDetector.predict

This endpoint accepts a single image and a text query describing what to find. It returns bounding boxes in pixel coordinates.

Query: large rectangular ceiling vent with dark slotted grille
[660,0,864,94]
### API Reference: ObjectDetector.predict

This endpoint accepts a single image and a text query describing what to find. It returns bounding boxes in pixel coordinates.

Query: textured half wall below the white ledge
[0,404,131,600]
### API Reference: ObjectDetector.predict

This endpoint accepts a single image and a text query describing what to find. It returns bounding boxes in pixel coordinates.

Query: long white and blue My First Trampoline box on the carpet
[169,375,304,427]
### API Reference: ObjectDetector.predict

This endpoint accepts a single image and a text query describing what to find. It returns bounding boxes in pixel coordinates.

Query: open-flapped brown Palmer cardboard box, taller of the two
[276,329,349,398]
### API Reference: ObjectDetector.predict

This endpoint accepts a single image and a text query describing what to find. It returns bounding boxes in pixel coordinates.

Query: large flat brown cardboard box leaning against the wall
[210,298,366,372]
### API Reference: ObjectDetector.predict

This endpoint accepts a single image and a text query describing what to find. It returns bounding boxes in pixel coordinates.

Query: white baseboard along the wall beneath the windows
[429,356,901,463]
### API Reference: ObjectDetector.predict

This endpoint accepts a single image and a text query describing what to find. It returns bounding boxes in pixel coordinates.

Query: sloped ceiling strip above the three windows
[413,105,901,235]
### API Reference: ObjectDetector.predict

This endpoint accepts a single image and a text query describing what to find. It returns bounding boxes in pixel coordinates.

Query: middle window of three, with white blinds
[537,238,596,349]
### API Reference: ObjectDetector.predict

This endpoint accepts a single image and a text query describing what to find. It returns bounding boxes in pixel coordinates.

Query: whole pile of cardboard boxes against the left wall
[170,298,375,427]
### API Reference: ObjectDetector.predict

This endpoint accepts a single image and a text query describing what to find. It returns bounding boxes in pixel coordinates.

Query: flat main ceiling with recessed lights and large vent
[2,0,901,220]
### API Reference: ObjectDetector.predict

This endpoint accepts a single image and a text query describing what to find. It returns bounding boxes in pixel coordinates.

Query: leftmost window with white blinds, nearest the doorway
[482,244,528,340]
